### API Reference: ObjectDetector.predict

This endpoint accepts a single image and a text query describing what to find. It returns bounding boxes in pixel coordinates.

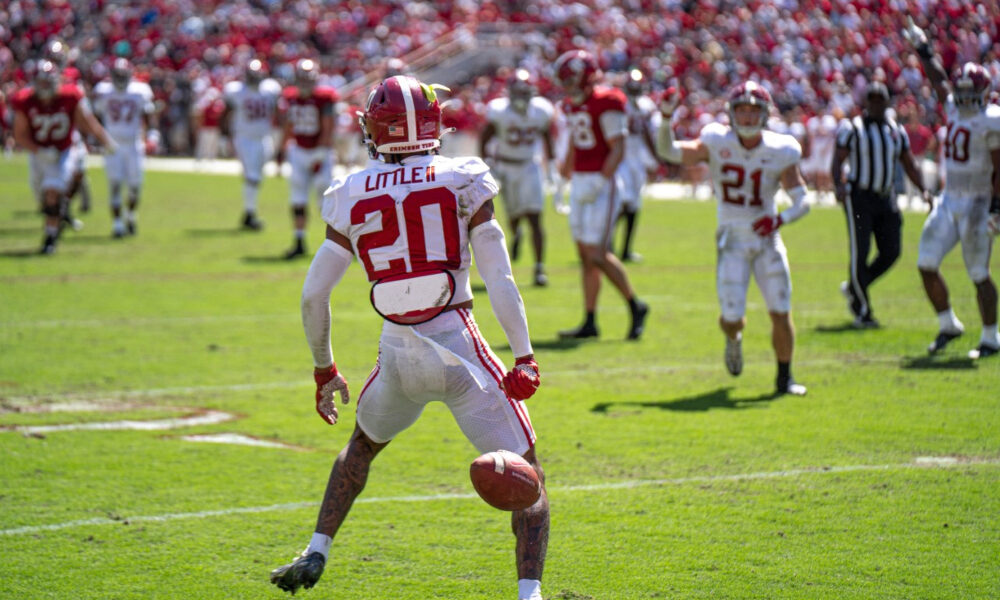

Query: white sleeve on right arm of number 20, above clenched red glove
[469,219,532,357]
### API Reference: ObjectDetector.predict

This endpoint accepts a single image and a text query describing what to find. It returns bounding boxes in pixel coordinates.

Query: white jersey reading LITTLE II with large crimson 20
[323,155,498,304]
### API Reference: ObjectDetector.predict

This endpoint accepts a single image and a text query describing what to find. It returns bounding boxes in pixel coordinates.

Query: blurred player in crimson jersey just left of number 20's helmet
[278,58,340,259]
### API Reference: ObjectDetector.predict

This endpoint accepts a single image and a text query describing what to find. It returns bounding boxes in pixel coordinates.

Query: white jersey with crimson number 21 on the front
[699,123,802,225]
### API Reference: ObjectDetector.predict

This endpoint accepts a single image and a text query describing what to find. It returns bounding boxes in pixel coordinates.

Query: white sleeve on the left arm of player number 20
[302,240,352,367]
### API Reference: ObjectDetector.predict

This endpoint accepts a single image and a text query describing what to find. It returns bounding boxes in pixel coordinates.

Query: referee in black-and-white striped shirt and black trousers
[830,81,930,329]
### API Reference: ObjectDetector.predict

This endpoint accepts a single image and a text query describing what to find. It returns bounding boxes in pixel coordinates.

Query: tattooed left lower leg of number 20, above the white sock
[316,425,389,538]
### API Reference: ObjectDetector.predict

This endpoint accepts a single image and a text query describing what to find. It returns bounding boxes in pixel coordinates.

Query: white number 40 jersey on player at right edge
[944,94,1000,196]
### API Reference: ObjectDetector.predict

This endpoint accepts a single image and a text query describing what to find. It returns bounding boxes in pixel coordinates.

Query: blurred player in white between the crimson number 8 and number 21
[618,69,661,262]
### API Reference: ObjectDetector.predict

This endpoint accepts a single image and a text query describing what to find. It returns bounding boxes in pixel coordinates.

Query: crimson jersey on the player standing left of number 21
[562,86,628,173]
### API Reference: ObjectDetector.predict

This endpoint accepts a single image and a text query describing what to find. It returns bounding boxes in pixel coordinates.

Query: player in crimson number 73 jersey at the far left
[11,60,117,254]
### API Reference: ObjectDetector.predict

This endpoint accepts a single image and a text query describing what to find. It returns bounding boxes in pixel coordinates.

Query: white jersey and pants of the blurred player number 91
[225,79,281,182]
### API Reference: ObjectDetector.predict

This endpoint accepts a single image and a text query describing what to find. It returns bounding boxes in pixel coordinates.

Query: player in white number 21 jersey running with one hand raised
[657,81,809,396]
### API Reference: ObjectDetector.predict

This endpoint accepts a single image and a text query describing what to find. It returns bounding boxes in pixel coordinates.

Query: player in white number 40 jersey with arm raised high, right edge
[904,19,1000,359]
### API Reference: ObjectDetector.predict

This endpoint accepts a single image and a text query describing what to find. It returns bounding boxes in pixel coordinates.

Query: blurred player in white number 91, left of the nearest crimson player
[221,58,281,231]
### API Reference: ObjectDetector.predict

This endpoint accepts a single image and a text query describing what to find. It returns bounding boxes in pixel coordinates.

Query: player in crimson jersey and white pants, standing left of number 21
[555,50,649,340]
